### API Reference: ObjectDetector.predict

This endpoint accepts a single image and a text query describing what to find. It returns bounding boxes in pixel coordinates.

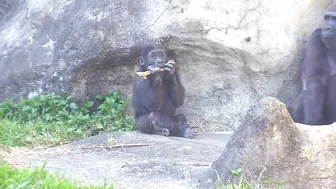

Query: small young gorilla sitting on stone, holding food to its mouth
[132,45,196,138]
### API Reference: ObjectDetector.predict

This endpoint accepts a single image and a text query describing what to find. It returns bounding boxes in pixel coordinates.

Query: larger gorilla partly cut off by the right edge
[287,3,336,125]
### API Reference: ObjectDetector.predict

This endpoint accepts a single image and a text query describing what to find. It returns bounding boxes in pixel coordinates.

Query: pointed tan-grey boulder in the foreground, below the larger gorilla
[212,97,336,189]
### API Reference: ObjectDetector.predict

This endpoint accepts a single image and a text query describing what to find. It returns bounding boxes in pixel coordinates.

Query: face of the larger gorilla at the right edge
[321,12,336,48]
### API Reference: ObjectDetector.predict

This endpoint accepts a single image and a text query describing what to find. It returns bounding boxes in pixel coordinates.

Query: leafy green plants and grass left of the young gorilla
[0,92,135,147]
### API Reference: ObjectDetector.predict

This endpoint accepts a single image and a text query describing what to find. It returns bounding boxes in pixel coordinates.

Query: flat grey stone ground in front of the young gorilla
[0,132,231,189]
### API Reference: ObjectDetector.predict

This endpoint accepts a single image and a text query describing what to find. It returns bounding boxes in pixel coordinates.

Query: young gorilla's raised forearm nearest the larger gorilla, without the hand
[169,73,185,108]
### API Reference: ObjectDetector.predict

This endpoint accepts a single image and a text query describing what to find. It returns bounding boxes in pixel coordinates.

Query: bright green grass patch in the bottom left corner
[0,162,114,189]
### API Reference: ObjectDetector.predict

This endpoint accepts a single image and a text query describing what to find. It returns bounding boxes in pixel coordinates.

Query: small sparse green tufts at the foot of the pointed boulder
[216,169,284,189]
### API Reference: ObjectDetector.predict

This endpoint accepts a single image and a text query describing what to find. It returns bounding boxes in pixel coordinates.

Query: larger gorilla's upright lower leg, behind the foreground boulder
[303,80,325,125]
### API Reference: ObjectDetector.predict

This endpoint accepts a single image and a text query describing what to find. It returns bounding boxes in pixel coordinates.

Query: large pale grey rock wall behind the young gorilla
[0,0,331,130]
